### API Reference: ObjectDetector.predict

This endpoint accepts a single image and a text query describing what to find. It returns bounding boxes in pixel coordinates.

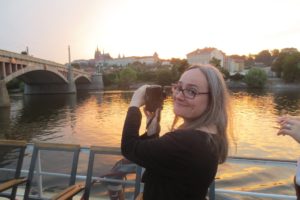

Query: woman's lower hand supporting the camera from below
[144,108,161,136]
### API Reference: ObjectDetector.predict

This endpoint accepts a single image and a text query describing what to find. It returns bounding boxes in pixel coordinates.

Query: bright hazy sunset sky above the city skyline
[0,0,300,63]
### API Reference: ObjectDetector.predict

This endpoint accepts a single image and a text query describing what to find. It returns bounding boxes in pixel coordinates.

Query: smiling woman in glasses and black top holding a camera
[121,66,228,200]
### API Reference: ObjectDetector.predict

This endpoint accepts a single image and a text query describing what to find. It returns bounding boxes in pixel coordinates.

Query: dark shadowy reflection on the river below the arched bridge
[0,94,81,141]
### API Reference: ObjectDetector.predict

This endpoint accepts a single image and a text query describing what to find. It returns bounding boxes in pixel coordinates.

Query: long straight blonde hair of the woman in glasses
[171,65,229,163]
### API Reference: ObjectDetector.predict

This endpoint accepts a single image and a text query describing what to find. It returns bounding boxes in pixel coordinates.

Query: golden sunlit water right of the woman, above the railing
[227,90,300,159]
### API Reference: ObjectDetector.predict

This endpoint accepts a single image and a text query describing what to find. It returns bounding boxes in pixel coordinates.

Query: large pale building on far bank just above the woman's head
[186,47,225,67]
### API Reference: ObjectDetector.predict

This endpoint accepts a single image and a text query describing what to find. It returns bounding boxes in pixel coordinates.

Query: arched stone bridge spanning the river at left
[0,50,103,107]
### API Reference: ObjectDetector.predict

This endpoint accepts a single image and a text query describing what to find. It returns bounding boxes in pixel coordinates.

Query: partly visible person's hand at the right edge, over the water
[277,116,300,143]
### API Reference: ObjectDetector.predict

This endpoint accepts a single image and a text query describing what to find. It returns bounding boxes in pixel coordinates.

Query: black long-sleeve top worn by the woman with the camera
[121,107,218,200]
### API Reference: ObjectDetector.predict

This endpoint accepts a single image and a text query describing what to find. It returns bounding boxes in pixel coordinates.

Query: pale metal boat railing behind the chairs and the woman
[0,144,297,200]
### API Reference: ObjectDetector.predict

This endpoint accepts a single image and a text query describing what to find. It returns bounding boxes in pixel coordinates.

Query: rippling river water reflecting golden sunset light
[0,89,300,199]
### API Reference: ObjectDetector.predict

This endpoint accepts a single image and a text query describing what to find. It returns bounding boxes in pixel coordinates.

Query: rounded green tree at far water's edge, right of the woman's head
[244,68,267,88]
